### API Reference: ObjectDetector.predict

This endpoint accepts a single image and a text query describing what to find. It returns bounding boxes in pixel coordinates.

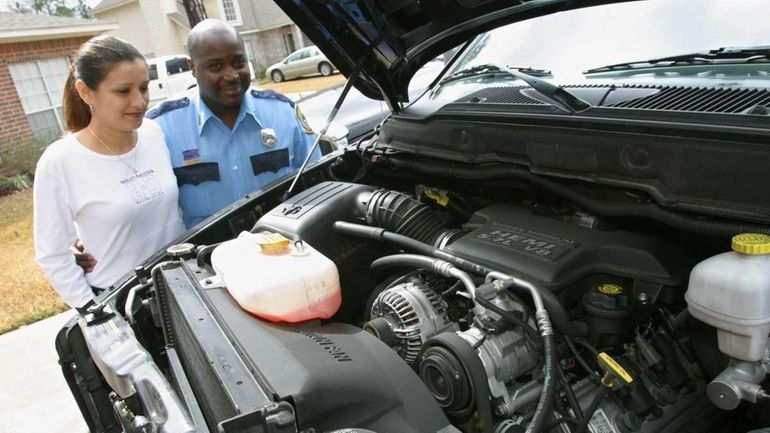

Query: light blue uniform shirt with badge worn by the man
[147,88,321,228]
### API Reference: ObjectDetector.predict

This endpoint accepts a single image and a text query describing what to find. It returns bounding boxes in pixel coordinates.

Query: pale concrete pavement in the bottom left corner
[0,311,88,433]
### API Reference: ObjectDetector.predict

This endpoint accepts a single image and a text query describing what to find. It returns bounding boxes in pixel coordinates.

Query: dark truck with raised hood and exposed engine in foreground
[57,0,770,433]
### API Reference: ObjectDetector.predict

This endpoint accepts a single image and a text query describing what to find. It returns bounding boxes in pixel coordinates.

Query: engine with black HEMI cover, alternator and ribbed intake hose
[246,183,720,432]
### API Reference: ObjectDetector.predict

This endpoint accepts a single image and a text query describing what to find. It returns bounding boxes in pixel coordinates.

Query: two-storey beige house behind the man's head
[91,0,312,73]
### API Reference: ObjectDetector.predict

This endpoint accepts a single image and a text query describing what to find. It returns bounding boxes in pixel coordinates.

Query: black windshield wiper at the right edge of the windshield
[583,46,770,75]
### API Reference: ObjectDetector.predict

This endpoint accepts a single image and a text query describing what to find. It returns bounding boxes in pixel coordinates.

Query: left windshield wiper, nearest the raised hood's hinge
[439,63,591,113]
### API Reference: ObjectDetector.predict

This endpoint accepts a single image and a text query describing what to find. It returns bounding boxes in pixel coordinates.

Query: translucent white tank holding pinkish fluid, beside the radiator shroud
[211,232,342,323]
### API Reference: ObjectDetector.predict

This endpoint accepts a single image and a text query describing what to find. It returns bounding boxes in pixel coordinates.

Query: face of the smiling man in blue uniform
[191,32,251,109]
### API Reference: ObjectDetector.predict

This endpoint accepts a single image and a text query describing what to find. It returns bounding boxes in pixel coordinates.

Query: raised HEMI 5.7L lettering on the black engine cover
[476,223,575,262]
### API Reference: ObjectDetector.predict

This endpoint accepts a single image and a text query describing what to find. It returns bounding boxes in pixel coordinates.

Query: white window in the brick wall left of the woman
[8,57,69,141]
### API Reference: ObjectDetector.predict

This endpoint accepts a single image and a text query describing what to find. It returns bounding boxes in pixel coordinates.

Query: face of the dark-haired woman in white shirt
[82,59,150,131]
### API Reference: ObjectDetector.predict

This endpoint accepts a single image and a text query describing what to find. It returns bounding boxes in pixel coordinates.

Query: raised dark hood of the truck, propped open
[276,0,629,109]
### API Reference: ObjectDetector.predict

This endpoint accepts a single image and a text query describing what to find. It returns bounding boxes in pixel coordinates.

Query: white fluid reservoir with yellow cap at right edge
[685,233,770,361]
